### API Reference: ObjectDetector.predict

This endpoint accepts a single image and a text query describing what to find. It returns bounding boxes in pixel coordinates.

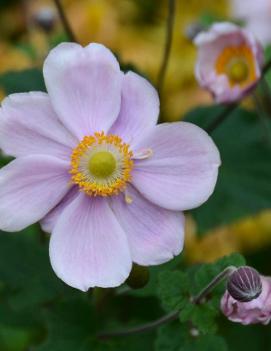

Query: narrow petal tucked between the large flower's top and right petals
[110,72,160,146]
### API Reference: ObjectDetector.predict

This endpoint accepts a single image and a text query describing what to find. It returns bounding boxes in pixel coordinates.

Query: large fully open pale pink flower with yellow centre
[0,43,220,291]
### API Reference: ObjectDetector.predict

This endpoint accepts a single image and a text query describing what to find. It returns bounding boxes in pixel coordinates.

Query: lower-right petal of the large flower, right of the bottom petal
[111,186,184,265]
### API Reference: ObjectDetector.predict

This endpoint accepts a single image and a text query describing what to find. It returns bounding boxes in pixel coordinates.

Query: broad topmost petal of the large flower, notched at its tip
[43,43,123,140]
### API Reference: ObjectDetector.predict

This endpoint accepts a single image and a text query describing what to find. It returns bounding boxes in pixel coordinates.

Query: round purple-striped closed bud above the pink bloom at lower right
[227,266,262,302]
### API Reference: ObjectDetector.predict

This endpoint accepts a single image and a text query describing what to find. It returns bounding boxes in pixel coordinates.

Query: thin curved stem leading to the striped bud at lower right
[98,266,236,340]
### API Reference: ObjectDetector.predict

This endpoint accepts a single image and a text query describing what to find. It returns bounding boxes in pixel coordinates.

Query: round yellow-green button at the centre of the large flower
[88,151,117,178]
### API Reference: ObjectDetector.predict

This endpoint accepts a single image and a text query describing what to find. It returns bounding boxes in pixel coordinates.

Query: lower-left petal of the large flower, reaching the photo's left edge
[0,155,70,232]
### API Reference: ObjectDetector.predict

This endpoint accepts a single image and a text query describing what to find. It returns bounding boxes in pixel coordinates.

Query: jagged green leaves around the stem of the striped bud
[158,254,248,334]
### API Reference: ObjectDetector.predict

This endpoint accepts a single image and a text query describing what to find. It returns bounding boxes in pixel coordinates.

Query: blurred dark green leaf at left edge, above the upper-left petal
[0,68,46,95]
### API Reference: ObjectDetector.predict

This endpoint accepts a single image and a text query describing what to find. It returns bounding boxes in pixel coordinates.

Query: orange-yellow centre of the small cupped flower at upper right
[215,44,256,86]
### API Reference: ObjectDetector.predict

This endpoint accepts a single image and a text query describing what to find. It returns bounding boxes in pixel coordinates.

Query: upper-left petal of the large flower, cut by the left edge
[0,92,76,158]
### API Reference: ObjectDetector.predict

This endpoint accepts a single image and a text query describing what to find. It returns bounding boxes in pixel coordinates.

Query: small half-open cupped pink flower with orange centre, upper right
[194,22,264,103]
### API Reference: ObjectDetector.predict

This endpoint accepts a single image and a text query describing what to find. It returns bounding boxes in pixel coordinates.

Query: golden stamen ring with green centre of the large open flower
[70,132,133,196]
